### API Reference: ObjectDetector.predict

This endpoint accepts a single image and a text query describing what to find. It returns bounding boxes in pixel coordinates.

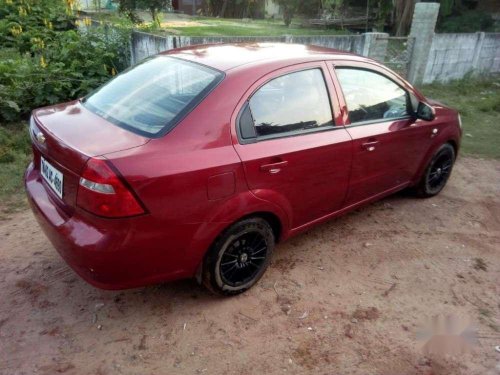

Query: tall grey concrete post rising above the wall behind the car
[408,3,440,85]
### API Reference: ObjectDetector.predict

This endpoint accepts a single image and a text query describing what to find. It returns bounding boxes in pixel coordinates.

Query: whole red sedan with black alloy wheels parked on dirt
[25,44,461,295]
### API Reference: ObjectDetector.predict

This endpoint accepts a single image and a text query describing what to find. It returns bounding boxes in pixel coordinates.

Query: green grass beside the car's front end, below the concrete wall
[421,75,500,159]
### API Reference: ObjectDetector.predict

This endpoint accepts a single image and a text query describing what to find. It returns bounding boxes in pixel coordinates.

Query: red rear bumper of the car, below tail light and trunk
[25,164,193,289]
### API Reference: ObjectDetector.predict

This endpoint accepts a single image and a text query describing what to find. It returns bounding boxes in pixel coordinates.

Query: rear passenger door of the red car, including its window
[234,62,351,228]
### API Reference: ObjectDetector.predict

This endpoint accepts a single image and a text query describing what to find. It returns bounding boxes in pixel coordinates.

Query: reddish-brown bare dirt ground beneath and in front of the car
[0,157,500,375]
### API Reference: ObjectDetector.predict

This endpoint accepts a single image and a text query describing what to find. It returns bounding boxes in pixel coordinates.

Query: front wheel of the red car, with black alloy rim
[415,143,455,198]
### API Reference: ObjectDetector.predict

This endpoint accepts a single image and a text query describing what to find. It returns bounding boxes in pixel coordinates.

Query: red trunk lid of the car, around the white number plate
[30,101,149,213]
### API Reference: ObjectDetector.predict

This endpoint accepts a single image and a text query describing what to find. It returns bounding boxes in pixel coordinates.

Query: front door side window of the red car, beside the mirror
[336,67,409,123]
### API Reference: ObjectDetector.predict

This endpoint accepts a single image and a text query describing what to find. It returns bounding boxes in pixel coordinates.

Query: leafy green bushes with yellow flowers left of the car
[0,0,129,121]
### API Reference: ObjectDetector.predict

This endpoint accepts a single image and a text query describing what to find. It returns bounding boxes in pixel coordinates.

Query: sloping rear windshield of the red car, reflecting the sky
[83,56,223,137]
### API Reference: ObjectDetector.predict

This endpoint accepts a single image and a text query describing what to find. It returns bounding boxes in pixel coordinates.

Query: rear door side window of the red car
[239,69,334,139]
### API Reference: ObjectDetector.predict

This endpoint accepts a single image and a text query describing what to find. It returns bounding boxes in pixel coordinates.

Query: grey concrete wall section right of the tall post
[423,33,500,83]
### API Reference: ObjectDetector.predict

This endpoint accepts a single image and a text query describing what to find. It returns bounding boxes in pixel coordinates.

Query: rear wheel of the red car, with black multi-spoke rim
[202,217,275,296]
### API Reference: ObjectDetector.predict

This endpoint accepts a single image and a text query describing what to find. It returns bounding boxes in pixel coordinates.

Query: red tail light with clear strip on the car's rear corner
[76,158,145,217]
